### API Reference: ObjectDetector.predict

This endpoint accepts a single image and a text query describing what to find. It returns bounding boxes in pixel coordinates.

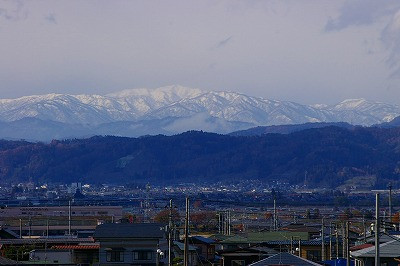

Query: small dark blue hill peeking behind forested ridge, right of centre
[229,122,354,136]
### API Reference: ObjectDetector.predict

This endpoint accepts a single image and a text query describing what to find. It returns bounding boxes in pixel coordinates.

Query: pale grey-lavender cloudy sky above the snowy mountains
[0,0,400,104]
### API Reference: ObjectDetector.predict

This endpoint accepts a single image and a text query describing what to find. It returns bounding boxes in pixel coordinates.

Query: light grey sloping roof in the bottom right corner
[350,239,400,258]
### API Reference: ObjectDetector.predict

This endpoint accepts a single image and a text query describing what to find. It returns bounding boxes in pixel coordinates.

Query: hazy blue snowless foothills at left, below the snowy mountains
[0,114,253,142]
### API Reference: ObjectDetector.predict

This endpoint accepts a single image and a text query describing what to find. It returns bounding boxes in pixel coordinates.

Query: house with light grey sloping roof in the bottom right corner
[350,238,400,266]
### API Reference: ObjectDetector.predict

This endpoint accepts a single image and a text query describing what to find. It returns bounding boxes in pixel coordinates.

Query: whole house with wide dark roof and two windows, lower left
[93,223,168,265]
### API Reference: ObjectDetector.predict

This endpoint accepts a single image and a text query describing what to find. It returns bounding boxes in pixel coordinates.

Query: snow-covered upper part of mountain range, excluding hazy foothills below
[0,85,400,130]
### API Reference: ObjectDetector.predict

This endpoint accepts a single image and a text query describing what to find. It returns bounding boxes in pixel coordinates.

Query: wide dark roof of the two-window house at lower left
[93,223,165,240]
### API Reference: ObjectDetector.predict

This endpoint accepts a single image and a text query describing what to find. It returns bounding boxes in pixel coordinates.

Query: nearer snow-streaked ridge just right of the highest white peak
[148,92,334,125]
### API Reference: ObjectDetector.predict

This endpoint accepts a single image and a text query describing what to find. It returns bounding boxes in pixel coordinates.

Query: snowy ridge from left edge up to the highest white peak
[0,86,200,125]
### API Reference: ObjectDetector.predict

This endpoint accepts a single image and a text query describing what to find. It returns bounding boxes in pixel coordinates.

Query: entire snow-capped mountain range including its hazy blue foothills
[0,86,400,139]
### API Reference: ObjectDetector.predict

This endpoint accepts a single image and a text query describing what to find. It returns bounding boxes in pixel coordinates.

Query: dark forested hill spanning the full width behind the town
[0,127,400,187]
